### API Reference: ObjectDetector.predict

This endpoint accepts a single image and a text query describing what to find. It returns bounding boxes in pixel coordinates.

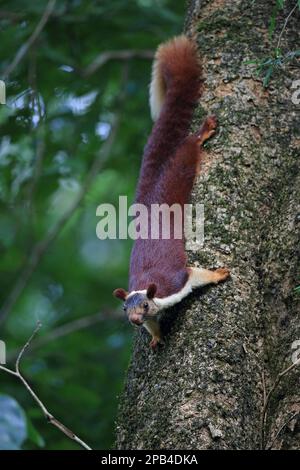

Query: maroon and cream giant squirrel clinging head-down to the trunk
[113,35,229,349]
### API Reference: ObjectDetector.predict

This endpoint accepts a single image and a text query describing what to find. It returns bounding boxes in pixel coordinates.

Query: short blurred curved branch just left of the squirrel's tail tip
[82,49,154,77]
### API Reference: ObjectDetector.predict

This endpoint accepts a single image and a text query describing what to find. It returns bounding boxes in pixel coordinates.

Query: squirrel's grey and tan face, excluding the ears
[123,293,158,326]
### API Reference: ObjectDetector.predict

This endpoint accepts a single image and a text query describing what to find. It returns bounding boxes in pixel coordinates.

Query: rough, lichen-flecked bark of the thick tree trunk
[117,0,300,449]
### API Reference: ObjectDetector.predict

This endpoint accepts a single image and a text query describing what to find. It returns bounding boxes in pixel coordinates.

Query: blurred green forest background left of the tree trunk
[0,0,185,449]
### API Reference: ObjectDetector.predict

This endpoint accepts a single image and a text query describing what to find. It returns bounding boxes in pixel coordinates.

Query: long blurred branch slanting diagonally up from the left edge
[0,115,119,324]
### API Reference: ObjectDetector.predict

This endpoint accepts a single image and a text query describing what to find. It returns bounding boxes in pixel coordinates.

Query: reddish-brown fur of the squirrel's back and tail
[129,38,209,298]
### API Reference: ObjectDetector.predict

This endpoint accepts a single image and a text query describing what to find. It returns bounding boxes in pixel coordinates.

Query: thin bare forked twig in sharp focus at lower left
[0,323,92,450]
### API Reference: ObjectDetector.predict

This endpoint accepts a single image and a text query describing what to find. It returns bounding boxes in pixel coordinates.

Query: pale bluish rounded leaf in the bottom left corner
[0,395,27,450]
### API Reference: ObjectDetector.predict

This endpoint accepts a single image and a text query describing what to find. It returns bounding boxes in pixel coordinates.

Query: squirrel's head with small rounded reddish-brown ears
[113,284,159,326]
